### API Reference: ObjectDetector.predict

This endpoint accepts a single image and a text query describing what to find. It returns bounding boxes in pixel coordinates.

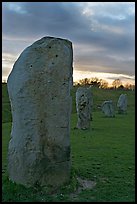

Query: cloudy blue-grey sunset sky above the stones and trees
[2,2,135,84]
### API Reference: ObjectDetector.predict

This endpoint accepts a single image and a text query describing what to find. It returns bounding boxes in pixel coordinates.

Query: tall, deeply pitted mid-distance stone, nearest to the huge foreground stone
[76,87,90,129]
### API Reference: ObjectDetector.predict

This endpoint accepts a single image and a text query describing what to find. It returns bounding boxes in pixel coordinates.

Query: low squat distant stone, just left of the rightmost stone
[102,100,115,117]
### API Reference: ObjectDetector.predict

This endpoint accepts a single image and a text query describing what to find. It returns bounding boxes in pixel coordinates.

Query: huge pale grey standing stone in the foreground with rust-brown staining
[8,37,73,186]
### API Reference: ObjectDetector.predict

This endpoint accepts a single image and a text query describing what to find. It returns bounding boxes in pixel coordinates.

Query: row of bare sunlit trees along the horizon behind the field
[74,77,135,90]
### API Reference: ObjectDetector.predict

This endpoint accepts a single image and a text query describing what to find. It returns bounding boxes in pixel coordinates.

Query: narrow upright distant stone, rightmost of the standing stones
[117,94,127,114]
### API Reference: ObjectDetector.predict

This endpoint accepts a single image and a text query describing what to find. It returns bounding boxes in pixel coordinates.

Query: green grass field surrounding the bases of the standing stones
[2,84,135,202]
